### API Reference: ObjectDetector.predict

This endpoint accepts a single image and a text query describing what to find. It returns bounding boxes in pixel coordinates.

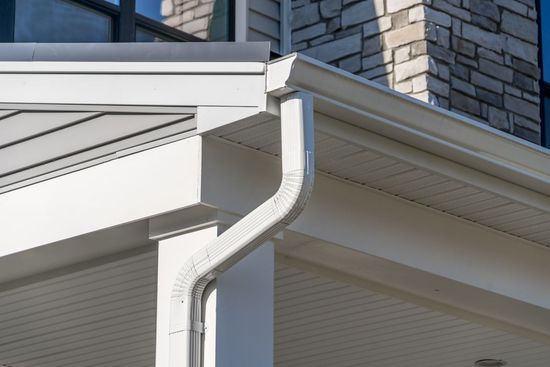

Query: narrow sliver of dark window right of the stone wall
[539,0,550,147]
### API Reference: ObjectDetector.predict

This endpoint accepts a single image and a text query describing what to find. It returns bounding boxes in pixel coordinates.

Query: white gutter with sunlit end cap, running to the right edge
[267,54,550,195]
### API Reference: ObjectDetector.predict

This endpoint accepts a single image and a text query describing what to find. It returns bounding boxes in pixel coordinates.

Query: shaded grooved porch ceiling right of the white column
[274,261,550,367]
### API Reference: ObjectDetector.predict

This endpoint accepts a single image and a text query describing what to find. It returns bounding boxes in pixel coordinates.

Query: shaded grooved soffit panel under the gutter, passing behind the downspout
[216,114,550,250]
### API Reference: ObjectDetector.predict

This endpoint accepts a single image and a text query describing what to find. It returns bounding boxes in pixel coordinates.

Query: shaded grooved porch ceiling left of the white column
[0,248,157,367]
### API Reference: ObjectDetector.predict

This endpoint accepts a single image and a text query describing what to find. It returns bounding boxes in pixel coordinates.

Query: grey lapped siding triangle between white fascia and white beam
[0,104,196,193]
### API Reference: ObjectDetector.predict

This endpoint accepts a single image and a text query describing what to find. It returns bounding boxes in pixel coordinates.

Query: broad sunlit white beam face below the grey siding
[0,136,202,257]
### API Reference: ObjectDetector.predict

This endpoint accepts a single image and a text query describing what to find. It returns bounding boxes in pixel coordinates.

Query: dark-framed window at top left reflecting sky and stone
[0,0,234,42]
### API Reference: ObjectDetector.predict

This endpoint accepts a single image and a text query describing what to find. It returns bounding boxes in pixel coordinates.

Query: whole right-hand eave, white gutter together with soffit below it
[216,54,550,246]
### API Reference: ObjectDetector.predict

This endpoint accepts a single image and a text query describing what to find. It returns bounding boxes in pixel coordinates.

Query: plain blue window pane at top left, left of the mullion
[15,0,112,42]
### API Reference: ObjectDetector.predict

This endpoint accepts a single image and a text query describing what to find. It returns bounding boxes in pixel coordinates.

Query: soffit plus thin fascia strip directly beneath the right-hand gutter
[212,113,550,246]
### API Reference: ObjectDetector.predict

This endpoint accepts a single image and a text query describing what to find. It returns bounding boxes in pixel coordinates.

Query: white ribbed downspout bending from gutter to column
[170,92,315,367]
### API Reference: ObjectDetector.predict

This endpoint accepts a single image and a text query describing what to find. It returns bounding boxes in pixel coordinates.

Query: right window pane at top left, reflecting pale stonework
[136,0,230,41]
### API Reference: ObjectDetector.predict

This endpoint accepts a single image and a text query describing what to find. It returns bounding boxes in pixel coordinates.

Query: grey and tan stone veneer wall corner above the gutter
[292,0,540,143]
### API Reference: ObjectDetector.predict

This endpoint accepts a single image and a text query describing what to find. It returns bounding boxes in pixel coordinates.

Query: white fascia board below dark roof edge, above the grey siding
[0,62,266,110]
